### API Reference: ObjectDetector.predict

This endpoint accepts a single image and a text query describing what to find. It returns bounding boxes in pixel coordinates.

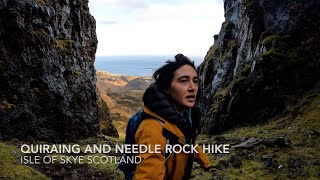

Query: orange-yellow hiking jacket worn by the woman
[133,107,211,180]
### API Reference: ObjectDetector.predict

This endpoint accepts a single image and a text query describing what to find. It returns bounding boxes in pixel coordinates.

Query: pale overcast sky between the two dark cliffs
[89,0,224,57]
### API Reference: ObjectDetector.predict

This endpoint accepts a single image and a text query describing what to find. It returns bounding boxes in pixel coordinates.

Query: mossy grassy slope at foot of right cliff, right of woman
[193,92,320,179]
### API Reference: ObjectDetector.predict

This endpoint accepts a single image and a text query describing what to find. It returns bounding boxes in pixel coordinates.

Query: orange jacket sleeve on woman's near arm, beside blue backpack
[133,120,166,180]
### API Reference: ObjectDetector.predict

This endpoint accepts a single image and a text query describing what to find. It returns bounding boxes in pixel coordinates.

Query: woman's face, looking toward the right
[166,65,199,108]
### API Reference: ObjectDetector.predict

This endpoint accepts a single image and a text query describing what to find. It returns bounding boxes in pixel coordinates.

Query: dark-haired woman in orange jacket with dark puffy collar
[133,54,211,179]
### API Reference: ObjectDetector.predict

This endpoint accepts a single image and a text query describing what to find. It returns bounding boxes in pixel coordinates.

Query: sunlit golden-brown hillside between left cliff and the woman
[97,71,153,138]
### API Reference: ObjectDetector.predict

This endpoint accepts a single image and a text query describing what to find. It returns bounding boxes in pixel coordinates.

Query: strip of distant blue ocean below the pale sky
[94,55,203,76]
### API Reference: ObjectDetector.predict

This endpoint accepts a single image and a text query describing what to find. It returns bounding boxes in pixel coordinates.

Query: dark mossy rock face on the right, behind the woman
[199,0,320,134]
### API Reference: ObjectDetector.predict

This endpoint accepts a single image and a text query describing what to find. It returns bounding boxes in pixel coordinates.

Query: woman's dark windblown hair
[153,54,197,90]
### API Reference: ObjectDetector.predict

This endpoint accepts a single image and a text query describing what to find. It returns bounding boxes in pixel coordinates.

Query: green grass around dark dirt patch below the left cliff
[0,135,123,179]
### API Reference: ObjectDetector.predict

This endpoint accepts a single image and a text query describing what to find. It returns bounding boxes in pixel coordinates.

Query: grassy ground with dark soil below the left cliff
[0,136,123,179]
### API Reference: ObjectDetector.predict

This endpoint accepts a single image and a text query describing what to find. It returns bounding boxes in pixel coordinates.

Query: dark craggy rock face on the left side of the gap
[0,0,115,142]
